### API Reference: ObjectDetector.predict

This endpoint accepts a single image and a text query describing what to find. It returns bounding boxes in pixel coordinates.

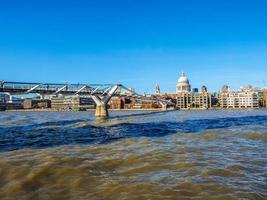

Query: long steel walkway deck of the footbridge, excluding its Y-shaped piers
[0,81,174,106]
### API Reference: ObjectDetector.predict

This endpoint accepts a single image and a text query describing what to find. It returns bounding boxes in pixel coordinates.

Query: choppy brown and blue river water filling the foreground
[0,110,267,200]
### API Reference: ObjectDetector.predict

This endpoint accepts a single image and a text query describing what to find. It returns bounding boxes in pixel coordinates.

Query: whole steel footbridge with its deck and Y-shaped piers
[0,81,175,118]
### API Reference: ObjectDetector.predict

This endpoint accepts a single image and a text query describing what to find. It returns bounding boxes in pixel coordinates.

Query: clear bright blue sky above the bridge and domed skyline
[0,0,267,92]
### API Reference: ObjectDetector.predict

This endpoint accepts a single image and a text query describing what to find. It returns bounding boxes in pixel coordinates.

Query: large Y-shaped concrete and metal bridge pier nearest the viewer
[92,85,120,118]
